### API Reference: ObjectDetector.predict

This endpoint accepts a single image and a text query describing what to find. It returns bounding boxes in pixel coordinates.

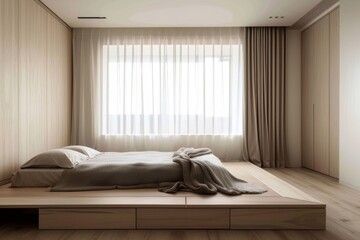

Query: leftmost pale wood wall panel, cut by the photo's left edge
[0,0,19,181]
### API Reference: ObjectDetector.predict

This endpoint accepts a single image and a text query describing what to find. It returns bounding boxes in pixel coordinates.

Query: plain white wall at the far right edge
[339,0,360,189]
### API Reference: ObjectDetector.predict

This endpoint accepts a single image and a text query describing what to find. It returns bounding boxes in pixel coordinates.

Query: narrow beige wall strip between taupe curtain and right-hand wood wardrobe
[286,30,301,167]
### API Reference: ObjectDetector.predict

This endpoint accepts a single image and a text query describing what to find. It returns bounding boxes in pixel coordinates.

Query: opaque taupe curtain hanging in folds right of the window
[243,27,287,167]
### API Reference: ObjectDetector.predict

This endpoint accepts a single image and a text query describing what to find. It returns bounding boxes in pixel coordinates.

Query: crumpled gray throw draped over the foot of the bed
[160,148,267,195]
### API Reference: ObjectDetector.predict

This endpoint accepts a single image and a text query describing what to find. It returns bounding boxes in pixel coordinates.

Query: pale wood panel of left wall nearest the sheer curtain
[47,13,71,149]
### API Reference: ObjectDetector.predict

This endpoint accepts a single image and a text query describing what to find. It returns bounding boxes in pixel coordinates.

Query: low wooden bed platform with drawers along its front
[0,162,326,229]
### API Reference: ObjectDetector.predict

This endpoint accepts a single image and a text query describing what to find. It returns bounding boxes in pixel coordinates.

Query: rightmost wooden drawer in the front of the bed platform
[230,208,326,229]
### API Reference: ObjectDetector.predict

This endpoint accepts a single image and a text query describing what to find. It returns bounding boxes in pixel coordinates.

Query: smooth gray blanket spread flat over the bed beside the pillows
[51,162,182,192]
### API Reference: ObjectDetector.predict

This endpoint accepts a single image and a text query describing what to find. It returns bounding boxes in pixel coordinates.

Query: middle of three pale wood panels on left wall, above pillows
[19,0,47,164]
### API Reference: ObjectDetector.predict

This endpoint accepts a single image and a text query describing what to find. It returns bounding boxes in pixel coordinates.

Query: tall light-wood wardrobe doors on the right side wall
[301,8,339,178]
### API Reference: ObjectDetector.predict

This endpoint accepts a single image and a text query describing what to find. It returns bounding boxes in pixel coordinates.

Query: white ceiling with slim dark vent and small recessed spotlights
[41,0,321,28]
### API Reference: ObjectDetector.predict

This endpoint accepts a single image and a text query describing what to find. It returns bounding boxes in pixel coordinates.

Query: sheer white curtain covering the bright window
[72,28,244,160]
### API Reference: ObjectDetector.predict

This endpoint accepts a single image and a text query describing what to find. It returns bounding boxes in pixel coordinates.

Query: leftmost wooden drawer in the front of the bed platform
[39,208,136,229]
